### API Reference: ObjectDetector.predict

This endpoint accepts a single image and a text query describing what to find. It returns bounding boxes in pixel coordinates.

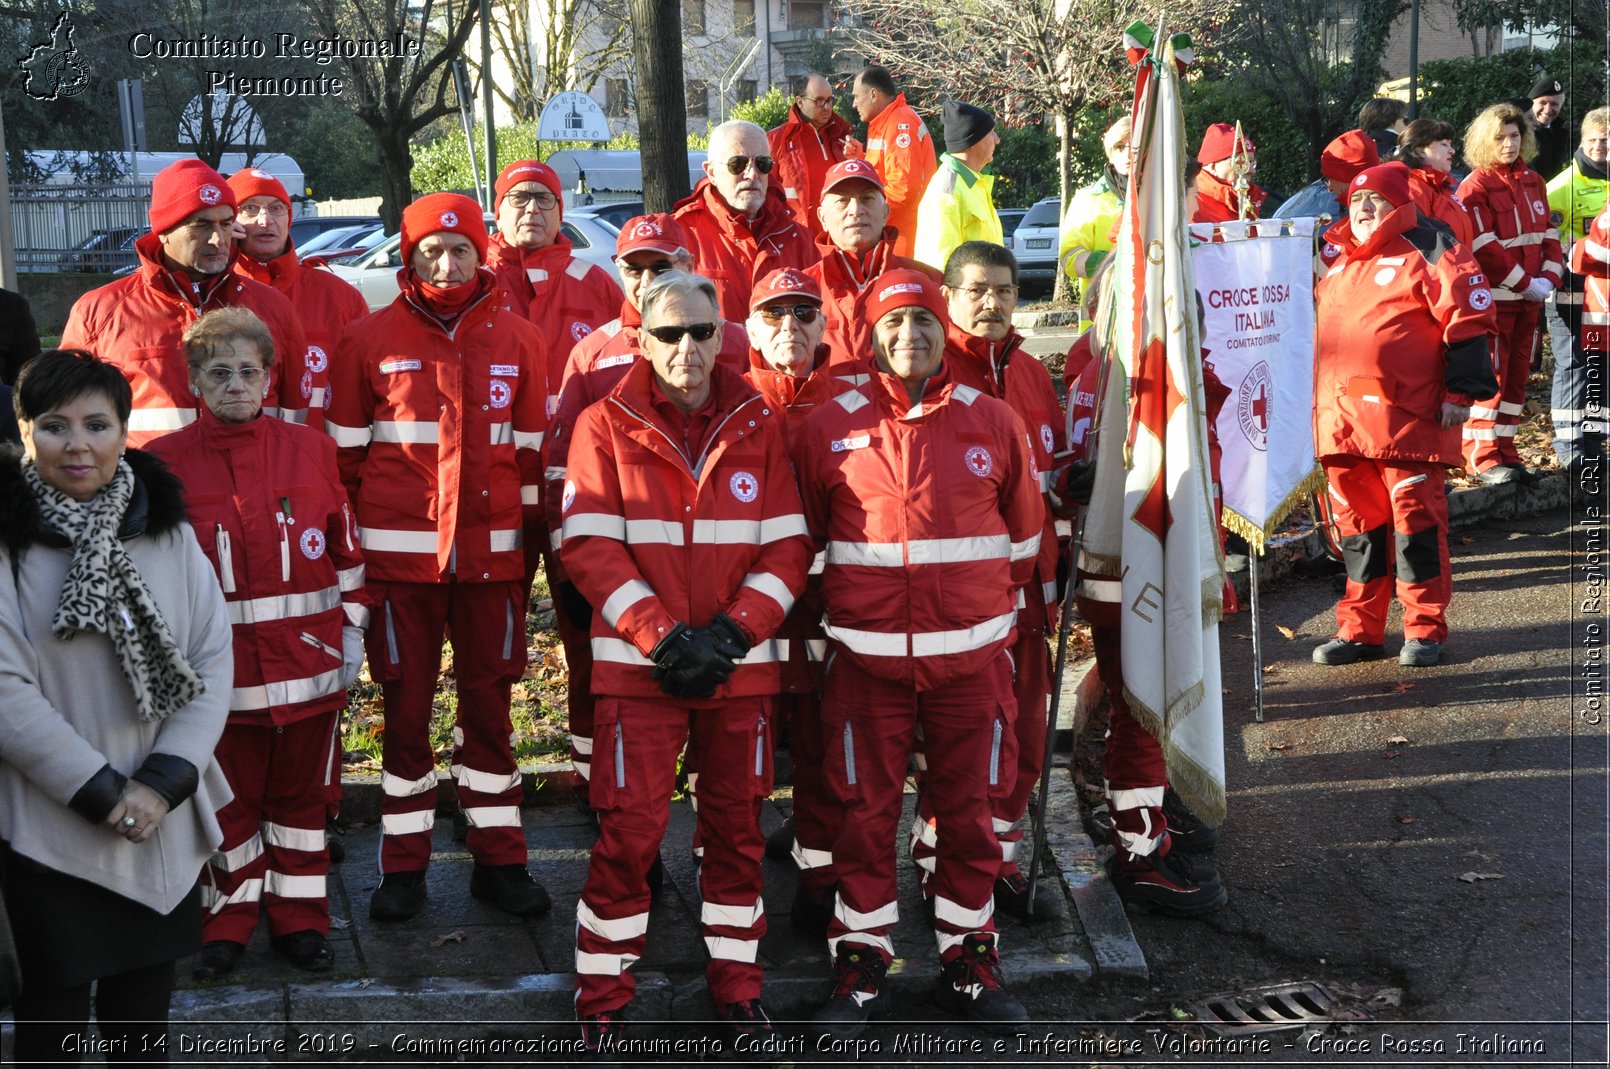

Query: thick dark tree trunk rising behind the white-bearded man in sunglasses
[630,0,689,211]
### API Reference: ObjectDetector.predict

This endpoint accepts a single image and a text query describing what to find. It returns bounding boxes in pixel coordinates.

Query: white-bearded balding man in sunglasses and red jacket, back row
[675,121,816,322]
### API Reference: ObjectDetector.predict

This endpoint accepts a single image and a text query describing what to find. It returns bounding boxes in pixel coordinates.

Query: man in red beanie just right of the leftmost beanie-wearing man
[229,167,369,427]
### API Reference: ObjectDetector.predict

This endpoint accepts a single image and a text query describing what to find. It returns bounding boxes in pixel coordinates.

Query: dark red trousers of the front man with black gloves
[576,697,773,1017]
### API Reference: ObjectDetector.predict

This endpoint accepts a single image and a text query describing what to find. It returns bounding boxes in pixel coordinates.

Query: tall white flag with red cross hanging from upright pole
[1080,27,1225,824]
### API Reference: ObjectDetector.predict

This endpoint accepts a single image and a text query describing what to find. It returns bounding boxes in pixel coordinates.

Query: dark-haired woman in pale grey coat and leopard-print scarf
[0,349,232,1064]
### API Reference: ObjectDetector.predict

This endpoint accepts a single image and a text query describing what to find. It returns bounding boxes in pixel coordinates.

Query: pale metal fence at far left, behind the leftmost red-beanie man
[11,182,151,272]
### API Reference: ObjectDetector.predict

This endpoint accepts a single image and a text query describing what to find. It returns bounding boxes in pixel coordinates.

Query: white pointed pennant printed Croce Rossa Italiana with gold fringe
[1193,221,1323,552]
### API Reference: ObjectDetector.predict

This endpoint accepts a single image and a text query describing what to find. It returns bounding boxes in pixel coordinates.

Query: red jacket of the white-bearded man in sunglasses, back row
[675,179,816,324]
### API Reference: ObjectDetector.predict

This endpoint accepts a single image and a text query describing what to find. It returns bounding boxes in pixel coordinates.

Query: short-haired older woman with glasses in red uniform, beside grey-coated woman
[151,307,369,979]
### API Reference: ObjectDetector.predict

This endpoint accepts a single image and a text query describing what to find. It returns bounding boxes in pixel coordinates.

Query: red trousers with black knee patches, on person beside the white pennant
[1323,456,1454,646]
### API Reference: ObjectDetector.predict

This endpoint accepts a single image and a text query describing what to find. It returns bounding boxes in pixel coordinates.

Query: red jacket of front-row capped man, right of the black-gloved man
[794,363,1045,691]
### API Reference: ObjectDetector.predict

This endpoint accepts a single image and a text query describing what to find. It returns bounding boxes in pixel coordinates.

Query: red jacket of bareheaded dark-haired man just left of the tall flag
[945,324,1067,625]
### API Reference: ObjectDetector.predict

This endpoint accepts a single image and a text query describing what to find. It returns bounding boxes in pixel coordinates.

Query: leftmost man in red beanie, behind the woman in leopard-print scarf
[61,159,308,446]
